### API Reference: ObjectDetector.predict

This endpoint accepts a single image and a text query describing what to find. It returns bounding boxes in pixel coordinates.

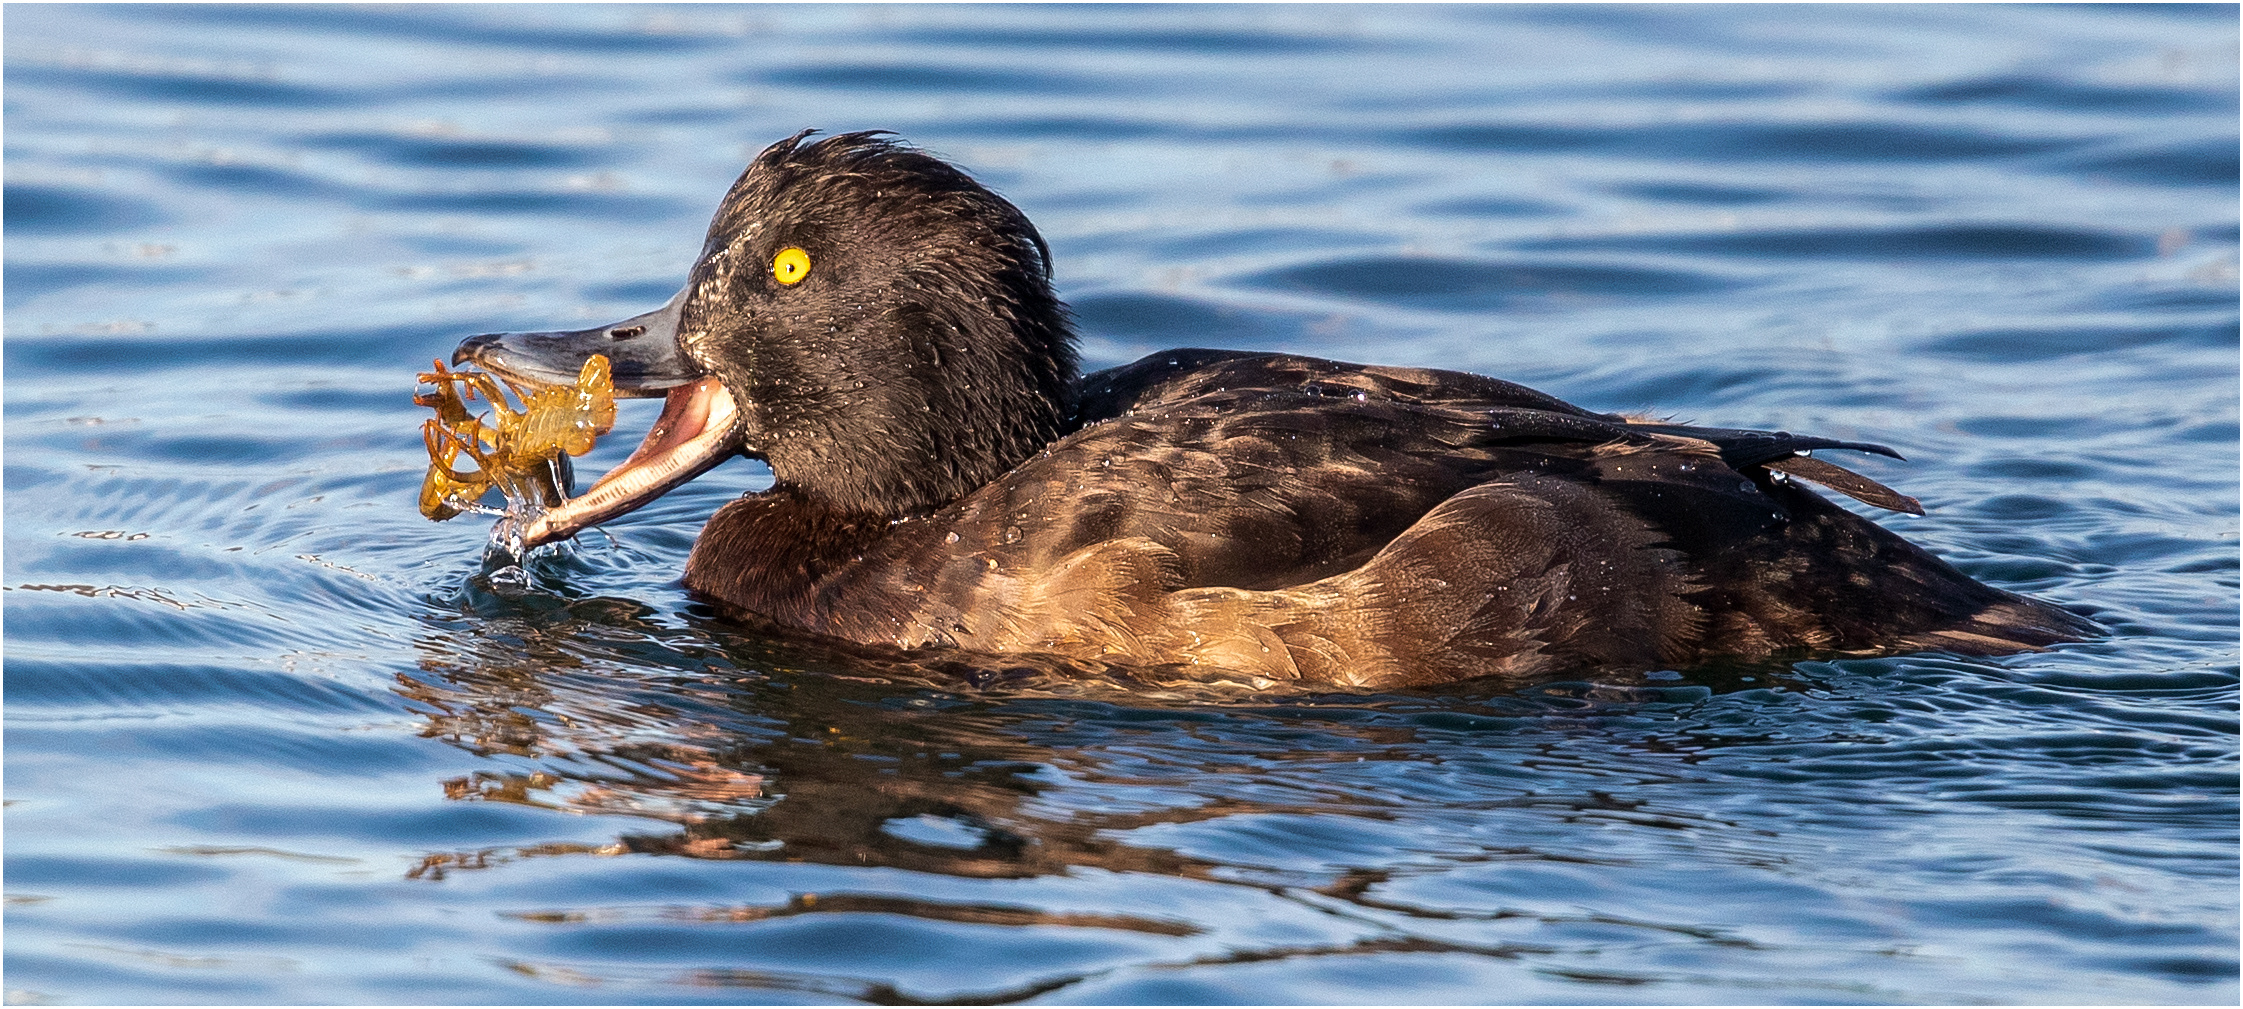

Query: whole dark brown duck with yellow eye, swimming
[453,130,2097,691]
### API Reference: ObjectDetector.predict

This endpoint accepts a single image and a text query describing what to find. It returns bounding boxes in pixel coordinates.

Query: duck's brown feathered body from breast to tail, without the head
[689,350,2090,686]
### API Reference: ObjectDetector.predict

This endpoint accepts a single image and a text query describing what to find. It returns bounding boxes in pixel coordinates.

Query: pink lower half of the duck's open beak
[523,379,740,549]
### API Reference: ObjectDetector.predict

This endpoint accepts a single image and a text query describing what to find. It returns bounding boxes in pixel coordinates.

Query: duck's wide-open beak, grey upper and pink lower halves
[451,291,742,549]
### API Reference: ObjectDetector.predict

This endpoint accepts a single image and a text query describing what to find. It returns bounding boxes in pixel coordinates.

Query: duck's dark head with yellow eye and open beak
[453,130,1074,545]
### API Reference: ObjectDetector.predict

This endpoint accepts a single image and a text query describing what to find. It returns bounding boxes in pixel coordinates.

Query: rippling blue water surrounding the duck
[4,7,2239,1002]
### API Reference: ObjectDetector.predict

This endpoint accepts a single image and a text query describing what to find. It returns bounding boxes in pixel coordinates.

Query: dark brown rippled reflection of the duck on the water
[397,599,1839,1002]
